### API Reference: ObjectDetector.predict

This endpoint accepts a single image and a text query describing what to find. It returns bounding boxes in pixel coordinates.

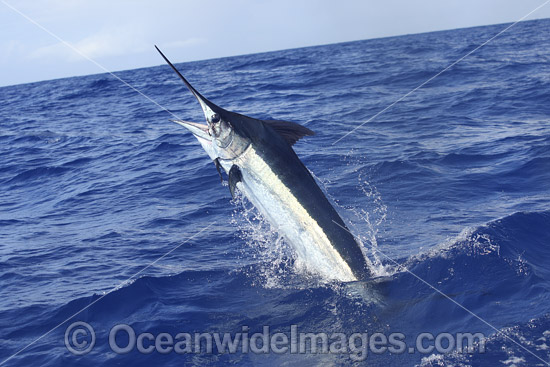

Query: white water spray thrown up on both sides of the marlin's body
[232,158,394,289]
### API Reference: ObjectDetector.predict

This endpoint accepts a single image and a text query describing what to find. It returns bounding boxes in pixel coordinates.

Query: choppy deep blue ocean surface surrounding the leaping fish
[0,20,550,366]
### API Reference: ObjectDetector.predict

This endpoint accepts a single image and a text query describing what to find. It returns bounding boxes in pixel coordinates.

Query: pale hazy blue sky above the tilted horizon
[0,0,550,86]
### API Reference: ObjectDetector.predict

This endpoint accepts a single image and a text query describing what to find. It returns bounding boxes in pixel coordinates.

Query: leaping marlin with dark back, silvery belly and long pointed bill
[155,46,371,282]
